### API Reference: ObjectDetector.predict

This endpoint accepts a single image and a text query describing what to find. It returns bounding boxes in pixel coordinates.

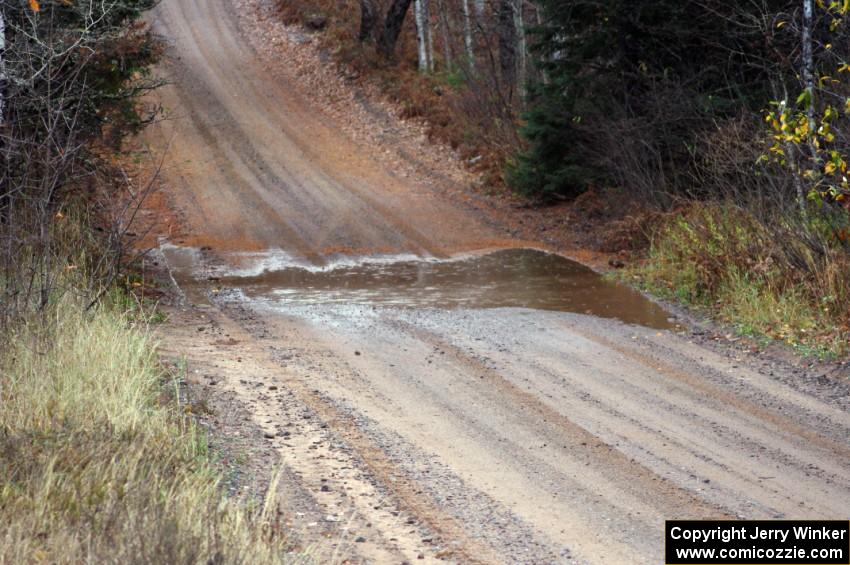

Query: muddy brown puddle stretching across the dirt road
[161,245,674,329]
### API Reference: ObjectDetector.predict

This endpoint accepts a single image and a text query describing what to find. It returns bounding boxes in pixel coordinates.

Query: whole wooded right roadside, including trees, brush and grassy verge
[279,0,850,351]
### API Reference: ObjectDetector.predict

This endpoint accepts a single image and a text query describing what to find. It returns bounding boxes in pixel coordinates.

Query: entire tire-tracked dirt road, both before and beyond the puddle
[150,0,850,564]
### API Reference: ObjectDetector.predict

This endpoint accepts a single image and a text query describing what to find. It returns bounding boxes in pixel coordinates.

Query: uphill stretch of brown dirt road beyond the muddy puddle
[145,0,507,261]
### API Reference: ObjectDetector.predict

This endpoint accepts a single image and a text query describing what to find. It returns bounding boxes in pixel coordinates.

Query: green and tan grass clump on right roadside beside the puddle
[623,203,850,358]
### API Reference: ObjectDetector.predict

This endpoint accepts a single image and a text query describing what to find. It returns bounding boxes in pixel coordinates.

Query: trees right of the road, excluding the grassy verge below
[310,0,847,205]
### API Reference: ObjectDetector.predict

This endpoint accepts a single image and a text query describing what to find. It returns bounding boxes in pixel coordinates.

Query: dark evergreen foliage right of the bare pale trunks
[508,0,816,203]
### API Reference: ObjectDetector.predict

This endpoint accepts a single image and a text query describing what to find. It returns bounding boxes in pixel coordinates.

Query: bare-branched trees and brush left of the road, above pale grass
[0,0,160,322]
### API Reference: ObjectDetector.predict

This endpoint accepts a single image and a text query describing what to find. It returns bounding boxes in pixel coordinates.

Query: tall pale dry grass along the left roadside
[0,295,298,564]
